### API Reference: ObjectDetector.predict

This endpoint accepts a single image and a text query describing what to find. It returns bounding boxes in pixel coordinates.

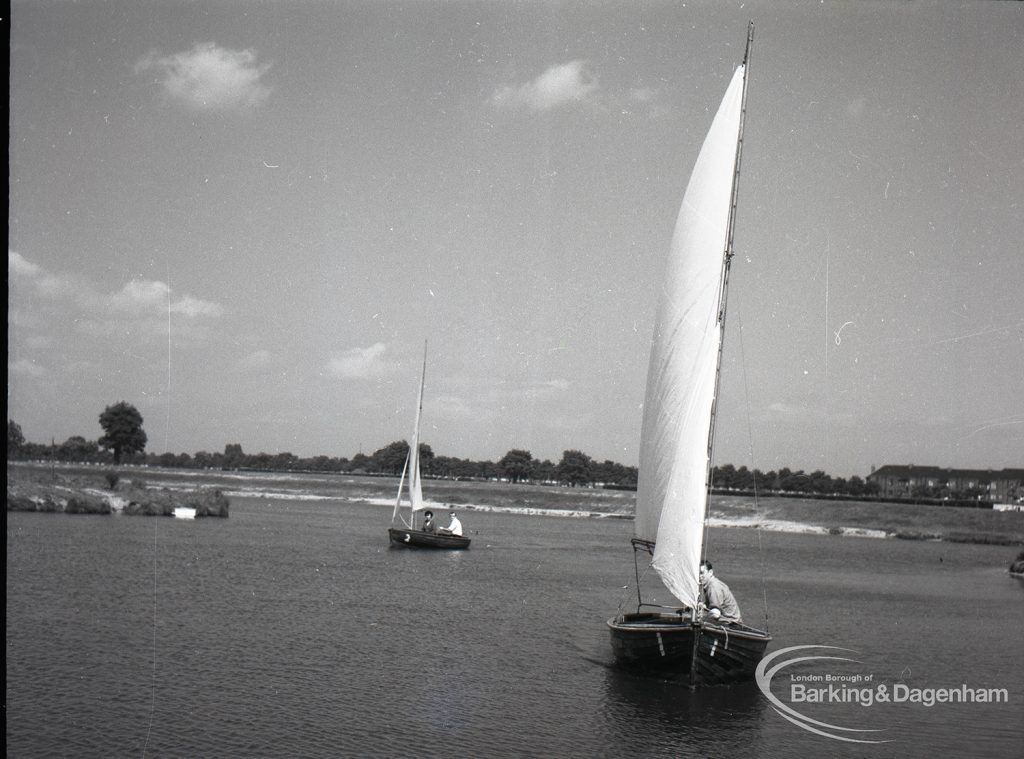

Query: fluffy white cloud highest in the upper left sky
[135,42,270,111]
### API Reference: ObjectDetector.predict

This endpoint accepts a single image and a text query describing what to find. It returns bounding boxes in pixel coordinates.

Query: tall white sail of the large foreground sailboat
[635,66,744,607]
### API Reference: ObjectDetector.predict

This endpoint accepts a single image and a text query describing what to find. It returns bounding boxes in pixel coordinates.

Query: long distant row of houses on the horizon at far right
[867,464,1024,503]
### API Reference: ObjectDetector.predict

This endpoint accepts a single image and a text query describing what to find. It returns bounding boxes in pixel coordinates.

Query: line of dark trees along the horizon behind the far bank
[7,400,878,497]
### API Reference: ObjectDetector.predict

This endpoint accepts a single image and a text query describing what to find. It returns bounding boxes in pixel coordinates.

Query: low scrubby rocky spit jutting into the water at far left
[7,474,230,518]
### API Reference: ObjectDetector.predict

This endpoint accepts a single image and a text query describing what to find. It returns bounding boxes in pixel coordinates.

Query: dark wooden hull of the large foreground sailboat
[608,613,771,685]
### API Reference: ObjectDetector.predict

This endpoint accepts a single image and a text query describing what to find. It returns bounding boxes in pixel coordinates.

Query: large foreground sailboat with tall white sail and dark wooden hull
[608,24,771,686]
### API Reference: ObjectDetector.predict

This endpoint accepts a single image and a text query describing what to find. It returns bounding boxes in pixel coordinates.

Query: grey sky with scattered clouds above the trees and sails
[7,0,1024,477]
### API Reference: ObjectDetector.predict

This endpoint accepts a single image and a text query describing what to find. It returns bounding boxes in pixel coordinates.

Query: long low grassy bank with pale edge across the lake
[7,462,1024,546]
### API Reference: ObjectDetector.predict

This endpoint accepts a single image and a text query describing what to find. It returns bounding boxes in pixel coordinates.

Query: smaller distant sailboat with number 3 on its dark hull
[387,345,470,550]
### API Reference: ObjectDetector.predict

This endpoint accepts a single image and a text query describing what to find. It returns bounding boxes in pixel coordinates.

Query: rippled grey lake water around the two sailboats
[5,473,1024,759]
